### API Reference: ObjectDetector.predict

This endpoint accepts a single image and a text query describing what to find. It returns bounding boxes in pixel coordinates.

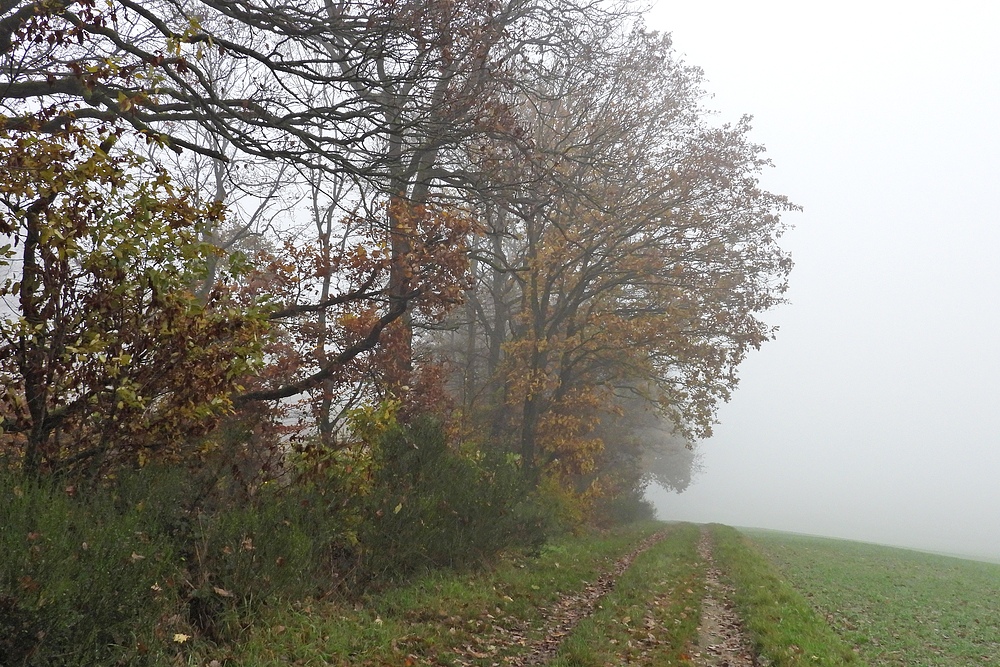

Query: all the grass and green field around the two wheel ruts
[94,523,1000,667]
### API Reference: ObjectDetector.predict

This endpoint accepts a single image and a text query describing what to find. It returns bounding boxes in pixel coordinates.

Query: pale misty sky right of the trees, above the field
[648,0,1000,558]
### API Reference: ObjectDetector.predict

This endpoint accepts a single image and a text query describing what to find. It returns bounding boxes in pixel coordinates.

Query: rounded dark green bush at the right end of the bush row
[358,419,551,582]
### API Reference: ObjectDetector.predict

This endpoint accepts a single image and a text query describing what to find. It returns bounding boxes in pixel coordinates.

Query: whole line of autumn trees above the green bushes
[0,0,794,517]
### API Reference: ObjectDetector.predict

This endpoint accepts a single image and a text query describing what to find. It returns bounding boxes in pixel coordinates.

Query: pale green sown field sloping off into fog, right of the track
[751,532,1000,667]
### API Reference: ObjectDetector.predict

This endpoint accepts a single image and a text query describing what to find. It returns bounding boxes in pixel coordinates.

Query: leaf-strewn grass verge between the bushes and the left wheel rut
[189,523,663,666]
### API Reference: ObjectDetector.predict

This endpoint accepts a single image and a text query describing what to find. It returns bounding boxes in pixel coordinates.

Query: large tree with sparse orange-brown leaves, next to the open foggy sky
[446,30,794,506]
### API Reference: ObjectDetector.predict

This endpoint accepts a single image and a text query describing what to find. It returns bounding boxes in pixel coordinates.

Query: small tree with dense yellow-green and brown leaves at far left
[0,126,270,475]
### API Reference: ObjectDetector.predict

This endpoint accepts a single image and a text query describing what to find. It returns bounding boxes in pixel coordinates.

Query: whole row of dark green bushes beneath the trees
[0,420,554,667]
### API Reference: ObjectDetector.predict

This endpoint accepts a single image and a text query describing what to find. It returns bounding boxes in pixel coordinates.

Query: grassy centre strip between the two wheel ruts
[549,525,705,667]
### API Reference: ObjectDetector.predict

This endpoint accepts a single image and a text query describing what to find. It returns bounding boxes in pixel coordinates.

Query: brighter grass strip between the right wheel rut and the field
[712,526,862,667]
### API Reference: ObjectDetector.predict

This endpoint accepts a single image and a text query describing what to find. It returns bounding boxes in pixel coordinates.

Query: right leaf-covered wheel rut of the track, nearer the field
[691,529,766,667]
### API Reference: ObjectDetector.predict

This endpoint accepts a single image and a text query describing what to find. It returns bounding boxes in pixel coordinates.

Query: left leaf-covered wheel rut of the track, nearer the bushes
[507,531,668,667]
